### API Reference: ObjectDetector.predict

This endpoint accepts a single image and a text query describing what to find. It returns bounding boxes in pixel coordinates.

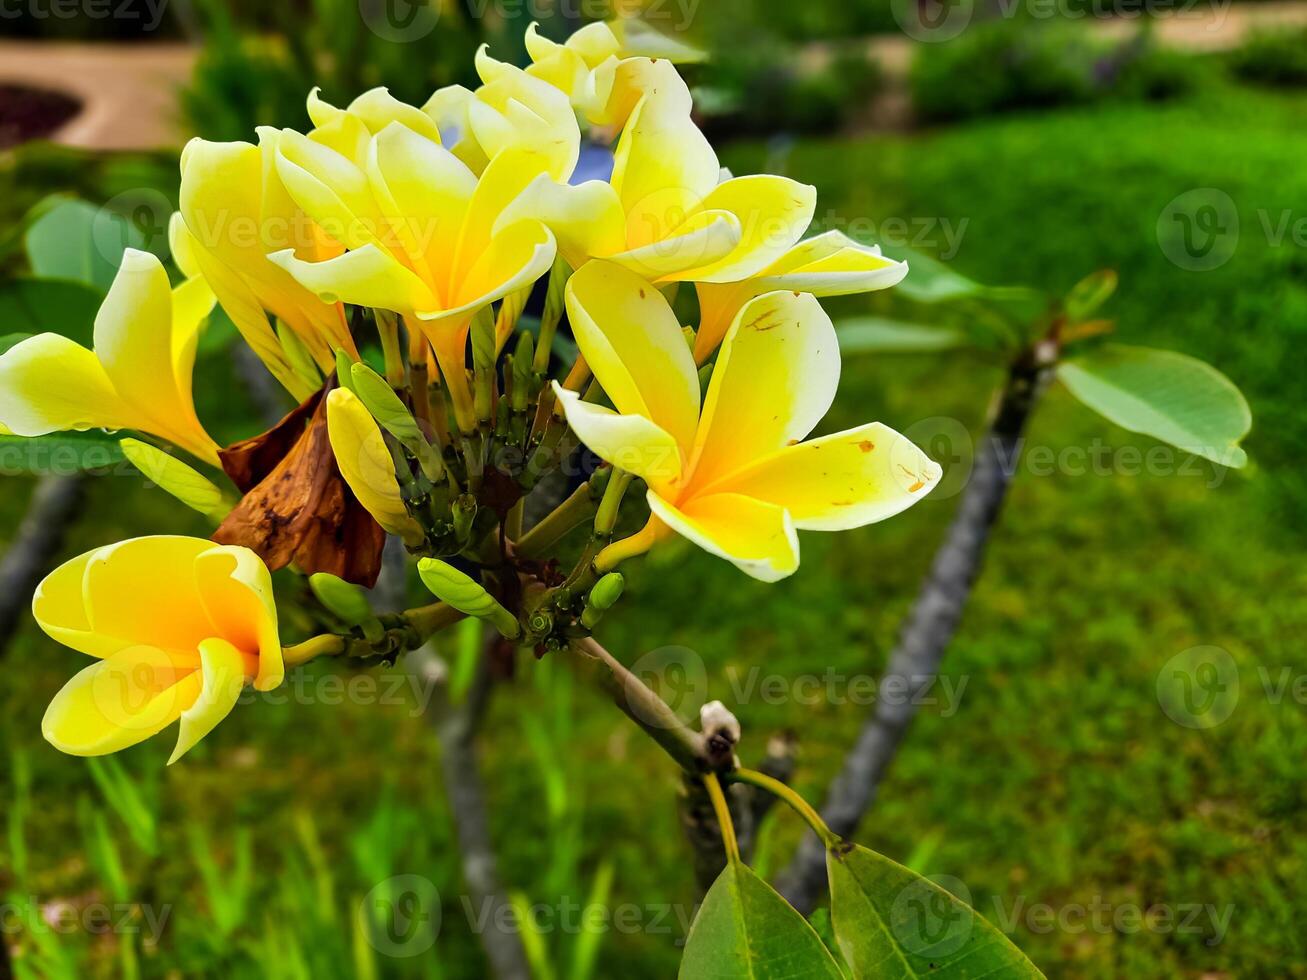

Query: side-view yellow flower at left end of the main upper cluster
[171,128,354,400]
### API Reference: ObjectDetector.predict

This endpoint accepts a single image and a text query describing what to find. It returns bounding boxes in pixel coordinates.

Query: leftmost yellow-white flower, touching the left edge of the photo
[0,248,218,464]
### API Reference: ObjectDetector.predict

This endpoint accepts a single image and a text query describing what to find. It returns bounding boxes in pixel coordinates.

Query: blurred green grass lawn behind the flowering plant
[0,80,1307,980]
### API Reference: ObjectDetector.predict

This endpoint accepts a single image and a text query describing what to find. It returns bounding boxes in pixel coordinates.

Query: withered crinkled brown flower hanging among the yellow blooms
[213,378,386,588]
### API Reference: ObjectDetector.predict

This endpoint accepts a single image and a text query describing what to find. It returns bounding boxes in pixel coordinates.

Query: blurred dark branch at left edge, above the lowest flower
[0,476,84,661]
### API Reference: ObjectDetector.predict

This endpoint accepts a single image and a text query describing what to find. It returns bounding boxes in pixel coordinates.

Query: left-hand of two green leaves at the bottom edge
[678,861,843,980]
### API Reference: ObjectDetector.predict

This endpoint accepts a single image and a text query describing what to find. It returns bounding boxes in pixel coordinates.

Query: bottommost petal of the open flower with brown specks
[648,490,799,581]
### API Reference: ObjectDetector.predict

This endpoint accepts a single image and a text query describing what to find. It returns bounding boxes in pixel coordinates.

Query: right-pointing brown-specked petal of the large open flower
[701,422,942,531]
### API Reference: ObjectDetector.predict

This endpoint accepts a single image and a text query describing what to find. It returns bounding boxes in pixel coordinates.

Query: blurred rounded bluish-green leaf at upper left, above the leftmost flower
[25,199,145,291]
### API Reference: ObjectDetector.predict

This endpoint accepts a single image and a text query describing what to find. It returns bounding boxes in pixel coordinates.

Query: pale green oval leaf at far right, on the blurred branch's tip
[1057,344,1252,466]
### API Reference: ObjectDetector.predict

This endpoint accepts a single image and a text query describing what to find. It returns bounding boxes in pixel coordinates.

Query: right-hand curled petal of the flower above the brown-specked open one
[684,174,817,282]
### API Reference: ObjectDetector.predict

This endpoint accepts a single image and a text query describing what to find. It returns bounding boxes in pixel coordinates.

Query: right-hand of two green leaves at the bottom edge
[826,844,1043,980]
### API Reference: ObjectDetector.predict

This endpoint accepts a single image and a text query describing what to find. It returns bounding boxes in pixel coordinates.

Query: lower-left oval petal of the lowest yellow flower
[41,647,203,755]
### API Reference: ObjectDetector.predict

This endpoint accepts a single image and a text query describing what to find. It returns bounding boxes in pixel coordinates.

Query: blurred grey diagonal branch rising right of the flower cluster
[776,349,1052,915]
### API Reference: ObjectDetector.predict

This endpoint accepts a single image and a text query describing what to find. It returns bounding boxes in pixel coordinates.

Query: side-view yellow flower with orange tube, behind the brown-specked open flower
[694,231,907,363]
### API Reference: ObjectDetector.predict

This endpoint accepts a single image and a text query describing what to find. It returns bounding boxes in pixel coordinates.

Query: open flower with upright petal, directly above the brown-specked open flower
[510,82,817,284]
